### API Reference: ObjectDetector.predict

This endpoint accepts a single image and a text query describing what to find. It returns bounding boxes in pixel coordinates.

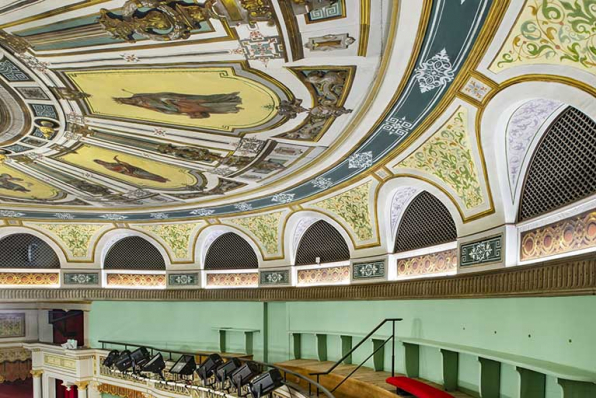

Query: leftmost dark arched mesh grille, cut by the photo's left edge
[0,234,60,268]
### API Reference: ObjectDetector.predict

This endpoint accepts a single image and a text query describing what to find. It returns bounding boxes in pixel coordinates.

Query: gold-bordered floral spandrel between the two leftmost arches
[23,222,114,262]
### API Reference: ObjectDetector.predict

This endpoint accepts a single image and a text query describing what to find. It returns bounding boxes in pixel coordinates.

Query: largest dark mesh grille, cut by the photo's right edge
[518,107,596,221]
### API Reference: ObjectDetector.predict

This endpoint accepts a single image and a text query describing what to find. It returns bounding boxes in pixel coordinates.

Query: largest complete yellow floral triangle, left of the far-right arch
[398,107,484,209]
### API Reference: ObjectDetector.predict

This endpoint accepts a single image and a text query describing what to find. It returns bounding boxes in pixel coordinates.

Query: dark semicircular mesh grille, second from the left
[103,236,166,271]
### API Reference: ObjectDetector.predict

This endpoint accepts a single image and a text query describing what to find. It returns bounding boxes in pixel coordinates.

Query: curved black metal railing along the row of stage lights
[99,340,335,398]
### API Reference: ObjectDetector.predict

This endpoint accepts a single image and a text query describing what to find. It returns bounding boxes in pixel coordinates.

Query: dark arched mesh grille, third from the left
[205,232,259,270]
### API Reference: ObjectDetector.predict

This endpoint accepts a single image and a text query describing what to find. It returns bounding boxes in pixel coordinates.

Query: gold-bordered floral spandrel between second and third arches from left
[130,221,208,263]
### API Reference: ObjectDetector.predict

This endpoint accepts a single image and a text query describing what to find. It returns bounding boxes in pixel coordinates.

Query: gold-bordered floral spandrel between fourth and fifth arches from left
[305,179,380,248]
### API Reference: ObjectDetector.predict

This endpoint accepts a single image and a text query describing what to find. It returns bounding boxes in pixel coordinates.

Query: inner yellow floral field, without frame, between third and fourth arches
[227,211,283,255]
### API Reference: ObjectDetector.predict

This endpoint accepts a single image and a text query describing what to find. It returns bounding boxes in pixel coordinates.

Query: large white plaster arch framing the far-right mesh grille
[480,81,596,223]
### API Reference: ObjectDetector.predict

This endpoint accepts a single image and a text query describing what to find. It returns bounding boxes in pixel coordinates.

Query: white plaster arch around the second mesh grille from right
[377,177,464,253]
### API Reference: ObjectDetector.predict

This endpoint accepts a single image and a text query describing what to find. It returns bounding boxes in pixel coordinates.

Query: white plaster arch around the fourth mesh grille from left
[283,210,356,265]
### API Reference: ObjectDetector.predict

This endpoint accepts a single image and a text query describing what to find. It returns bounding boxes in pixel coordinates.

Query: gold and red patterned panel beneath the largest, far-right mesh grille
[521,209,596,261]
